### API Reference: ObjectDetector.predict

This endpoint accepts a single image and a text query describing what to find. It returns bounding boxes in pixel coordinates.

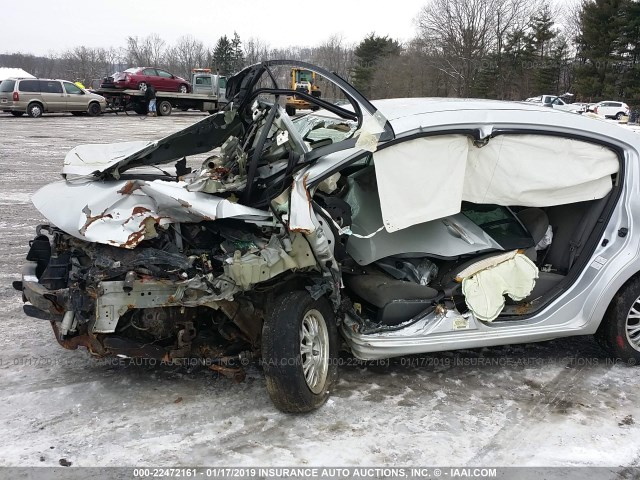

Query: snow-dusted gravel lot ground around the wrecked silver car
[0,113,640,472]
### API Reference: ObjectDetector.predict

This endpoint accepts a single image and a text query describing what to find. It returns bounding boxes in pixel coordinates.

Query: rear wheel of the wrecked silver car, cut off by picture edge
[596,278,640,365]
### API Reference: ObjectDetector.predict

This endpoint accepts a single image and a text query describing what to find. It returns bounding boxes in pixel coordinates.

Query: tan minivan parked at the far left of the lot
[0,78,107,118]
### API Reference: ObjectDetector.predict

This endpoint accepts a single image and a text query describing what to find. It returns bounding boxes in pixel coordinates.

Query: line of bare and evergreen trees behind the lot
[0,0,640,106]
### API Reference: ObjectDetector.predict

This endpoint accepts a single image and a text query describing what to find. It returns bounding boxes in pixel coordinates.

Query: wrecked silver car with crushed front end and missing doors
[14,60,640,412]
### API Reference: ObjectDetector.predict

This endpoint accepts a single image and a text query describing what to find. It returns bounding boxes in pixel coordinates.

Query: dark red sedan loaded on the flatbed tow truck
[100,67,191,93]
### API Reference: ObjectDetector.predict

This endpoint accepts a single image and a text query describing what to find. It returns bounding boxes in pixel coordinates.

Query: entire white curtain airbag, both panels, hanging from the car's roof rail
[374,134,618,232]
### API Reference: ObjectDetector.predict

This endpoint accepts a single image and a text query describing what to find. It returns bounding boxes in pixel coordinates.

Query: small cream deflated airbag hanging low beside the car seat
[462,253,538,322]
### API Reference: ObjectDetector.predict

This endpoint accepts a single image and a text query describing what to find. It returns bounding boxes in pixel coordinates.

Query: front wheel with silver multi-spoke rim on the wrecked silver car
[262,291,339,413]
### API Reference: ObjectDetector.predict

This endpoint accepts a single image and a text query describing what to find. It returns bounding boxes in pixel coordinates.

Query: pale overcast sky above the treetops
[0,0,427,55]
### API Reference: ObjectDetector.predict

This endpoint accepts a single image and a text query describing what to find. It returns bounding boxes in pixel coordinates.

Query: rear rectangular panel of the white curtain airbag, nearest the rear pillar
[462,135,618,207]
